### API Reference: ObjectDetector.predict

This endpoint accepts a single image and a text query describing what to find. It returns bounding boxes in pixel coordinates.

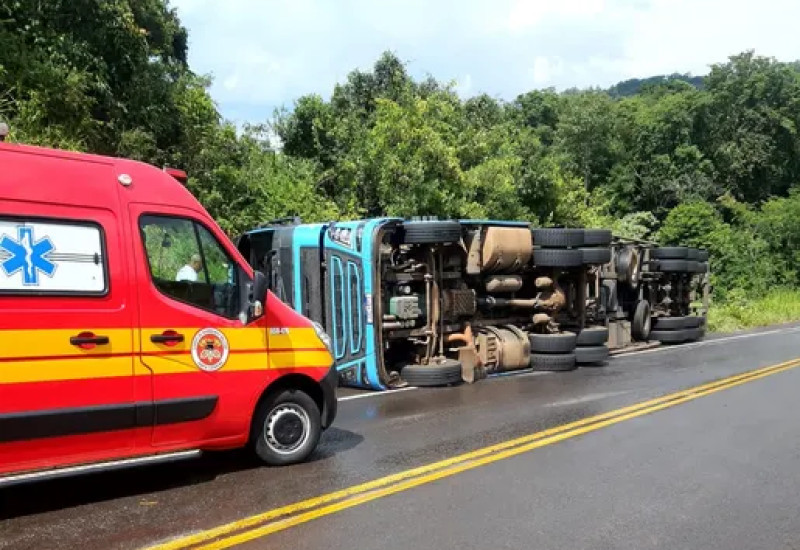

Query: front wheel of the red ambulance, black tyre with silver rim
[250,390,322,466]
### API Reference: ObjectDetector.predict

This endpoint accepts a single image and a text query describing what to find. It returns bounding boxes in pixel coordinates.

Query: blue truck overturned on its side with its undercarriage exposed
[239,218,712,389]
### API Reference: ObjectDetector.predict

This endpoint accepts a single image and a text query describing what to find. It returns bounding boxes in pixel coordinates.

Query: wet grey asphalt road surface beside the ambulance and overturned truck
[0,327,800,550]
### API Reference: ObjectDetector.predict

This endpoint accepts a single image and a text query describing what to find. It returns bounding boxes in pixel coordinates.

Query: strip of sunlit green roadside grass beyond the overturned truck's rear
[708,289,800,332]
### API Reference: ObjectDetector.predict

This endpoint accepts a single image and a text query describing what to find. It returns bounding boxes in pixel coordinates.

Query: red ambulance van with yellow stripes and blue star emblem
[0,140,336,484]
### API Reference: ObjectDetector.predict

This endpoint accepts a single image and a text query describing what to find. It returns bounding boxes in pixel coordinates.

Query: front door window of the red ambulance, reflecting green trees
[139,216,239,318]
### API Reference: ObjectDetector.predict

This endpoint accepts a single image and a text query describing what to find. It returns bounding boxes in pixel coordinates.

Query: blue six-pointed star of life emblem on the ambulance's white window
[0,225,56,286]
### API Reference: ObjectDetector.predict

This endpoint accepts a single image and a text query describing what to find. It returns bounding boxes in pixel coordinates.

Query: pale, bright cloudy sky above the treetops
[171,0,800,122]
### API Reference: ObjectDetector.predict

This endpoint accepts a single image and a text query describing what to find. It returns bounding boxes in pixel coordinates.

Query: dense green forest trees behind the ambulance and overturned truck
[0,0,800,320]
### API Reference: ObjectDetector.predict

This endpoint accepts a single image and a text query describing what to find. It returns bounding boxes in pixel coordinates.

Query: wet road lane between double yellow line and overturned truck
[0,328,800,550]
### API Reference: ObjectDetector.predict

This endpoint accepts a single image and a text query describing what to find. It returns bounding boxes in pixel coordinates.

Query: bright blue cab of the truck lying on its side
[239,218,402,389]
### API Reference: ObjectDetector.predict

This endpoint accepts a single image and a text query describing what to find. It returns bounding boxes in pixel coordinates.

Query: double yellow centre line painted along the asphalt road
[151,358,800,550]
